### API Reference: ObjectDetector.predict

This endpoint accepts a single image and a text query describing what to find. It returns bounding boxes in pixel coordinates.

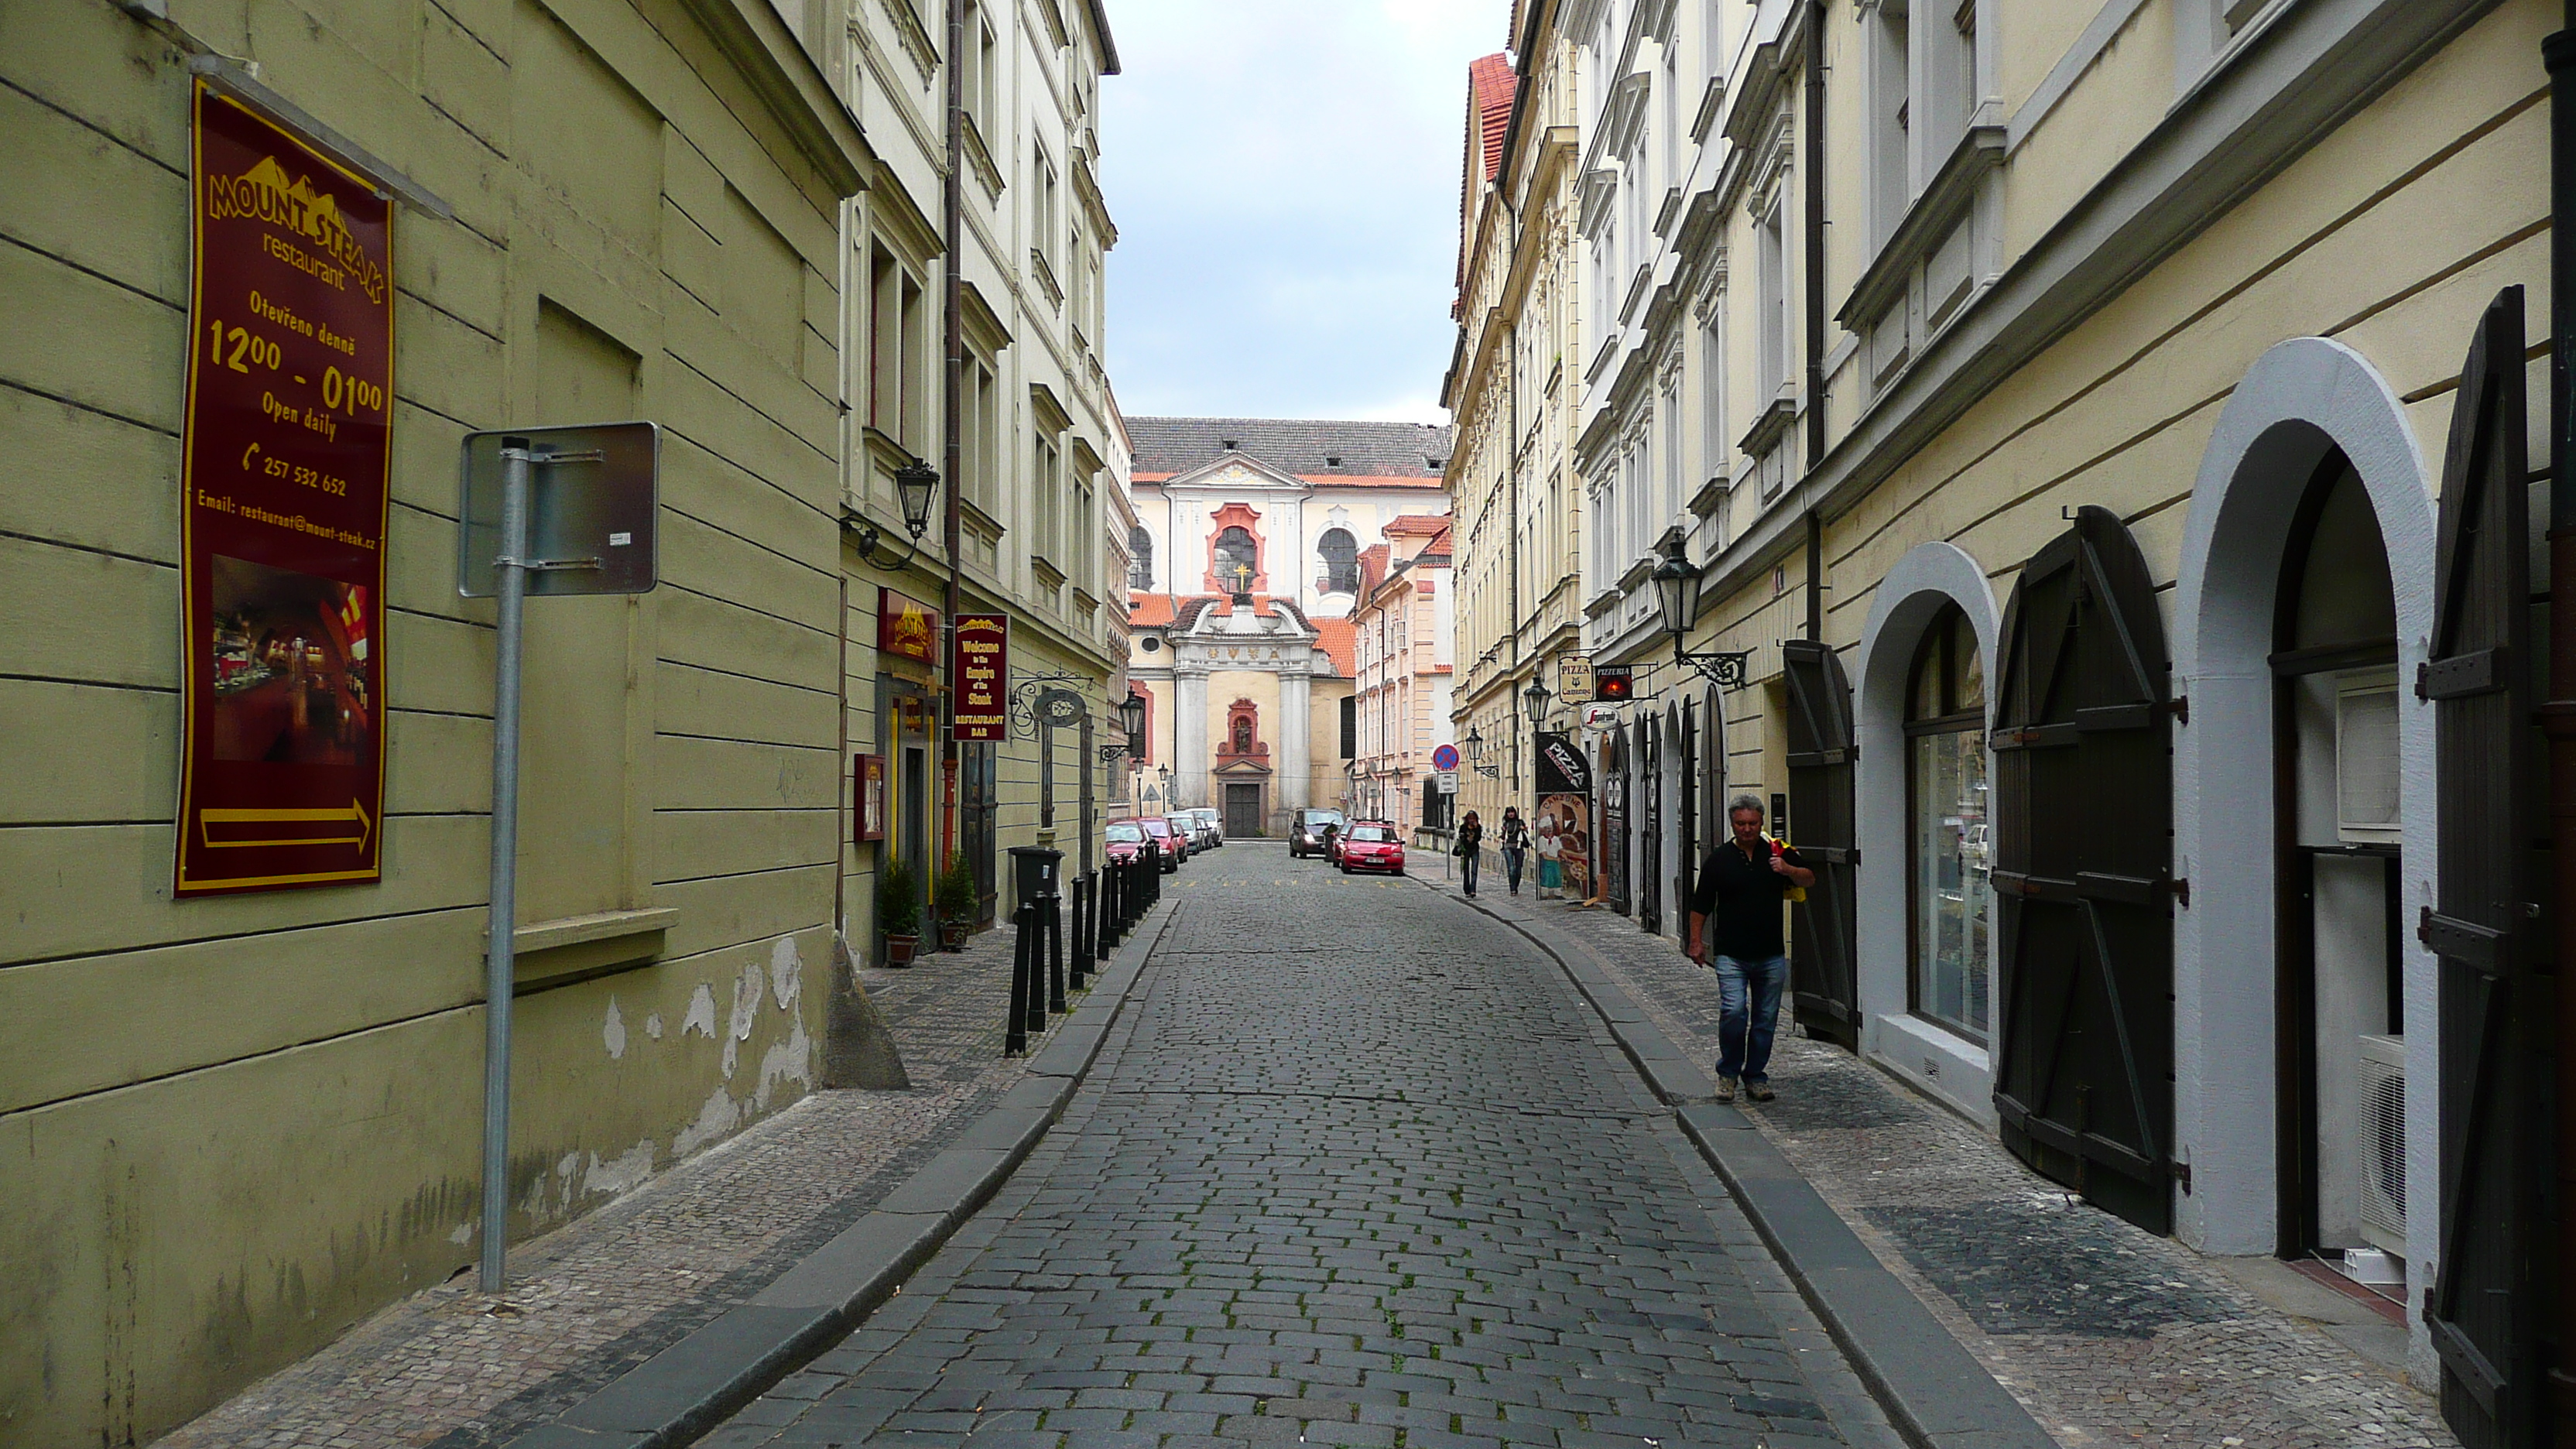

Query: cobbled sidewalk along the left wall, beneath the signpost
[159,926,1077,1449]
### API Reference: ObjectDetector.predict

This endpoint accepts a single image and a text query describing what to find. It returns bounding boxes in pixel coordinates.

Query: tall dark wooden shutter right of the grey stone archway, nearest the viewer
[2417,286,2550,1449]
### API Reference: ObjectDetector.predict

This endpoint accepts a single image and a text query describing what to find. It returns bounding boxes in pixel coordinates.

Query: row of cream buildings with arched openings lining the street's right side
[1445,0,2576,1447]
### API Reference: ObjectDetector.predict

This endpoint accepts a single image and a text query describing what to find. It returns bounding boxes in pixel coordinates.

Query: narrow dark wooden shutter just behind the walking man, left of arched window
[1780,639,1860,1050]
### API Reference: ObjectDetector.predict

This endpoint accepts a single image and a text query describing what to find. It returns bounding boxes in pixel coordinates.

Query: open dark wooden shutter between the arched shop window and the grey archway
[1992,508,2174,1232]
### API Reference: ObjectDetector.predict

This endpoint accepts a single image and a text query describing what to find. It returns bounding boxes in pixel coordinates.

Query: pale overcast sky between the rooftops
[1100,0,1509,423]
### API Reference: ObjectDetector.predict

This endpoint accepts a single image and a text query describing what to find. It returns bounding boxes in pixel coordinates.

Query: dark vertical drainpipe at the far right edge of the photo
[2540,14,2576,1444]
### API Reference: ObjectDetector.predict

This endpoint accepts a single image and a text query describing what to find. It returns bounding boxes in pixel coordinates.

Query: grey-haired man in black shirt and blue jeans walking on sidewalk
[1690,794,1816,1101]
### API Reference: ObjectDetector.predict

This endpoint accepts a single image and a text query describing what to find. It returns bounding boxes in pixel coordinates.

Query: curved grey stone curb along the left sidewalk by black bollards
[508,900,1180,1449]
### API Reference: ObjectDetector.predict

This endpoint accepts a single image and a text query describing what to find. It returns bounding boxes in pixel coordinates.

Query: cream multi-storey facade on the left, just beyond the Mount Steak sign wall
[844,0,1125,923]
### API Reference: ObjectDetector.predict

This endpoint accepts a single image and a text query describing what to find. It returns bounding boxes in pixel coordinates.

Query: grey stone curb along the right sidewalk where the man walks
[1424,882,2060,1449]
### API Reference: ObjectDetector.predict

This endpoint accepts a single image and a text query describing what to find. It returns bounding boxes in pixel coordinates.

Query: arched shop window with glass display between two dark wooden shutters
[1906,603,1994,1042]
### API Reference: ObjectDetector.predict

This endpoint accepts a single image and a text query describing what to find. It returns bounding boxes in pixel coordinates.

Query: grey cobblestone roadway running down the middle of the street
[704,841,1893,1449]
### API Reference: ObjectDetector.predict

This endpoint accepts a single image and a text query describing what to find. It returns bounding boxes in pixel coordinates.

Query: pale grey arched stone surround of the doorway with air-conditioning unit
[2172,337,2440,1320]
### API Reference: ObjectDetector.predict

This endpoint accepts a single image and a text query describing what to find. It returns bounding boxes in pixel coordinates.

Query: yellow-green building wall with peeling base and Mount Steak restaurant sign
[0,0,873,1447]
